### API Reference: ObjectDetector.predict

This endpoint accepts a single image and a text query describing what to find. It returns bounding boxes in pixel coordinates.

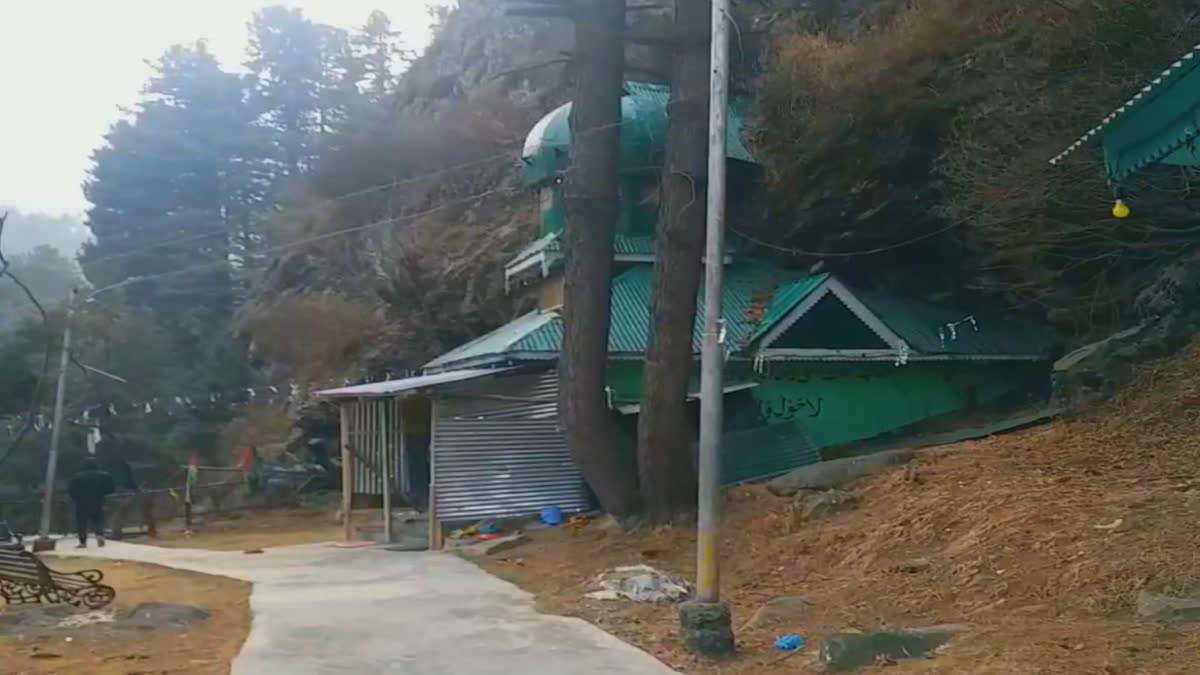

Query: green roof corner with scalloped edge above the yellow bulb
[1050,44,1200,183]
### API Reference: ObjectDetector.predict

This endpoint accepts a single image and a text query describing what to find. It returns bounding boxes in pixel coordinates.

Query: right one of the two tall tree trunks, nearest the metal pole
[637,0,712,516]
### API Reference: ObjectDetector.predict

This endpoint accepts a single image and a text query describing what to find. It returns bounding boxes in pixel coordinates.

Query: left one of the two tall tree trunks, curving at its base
[559,0,637,518]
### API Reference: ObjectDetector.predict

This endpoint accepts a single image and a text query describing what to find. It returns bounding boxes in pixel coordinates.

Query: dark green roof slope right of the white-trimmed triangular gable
[853,291,1052,357]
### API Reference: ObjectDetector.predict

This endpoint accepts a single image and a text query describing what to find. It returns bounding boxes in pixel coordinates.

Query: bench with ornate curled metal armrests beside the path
[0,551,116,609]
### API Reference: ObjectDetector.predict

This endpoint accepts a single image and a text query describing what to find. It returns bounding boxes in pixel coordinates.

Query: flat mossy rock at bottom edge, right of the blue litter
[818,626,964,671]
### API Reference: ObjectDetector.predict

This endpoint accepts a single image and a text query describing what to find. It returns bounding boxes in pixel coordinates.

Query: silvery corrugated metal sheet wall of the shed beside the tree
[433,371,590,521]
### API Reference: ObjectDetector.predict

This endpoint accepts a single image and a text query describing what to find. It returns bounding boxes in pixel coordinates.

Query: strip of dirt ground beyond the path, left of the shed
[150,509,342,551]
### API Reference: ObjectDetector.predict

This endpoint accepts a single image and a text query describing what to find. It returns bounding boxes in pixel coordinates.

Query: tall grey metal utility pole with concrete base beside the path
[679,0,733,656]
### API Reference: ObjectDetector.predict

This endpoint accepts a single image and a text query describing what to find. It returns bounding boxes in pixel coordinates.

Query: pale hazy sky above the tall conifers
[0,0,448,214]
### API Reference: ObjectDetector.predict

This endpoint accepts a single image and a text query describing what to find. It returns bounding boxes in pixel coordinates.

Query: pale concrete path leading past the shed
[51,542,673,675]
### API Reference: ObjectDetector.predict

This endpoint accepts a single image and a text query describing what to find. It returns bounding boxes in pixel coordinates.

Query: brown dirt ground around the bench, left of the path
[0,558,250,675]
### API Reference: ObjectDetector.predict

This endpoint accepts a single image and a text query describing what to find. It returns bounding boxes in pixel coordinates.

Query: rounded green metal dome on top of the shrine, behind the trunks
[521,82,754,183]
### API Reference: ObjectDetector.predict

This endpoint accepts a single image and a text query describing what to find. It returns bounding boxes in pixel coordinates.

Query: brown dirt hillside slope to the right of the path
[482,346,1200,675]
